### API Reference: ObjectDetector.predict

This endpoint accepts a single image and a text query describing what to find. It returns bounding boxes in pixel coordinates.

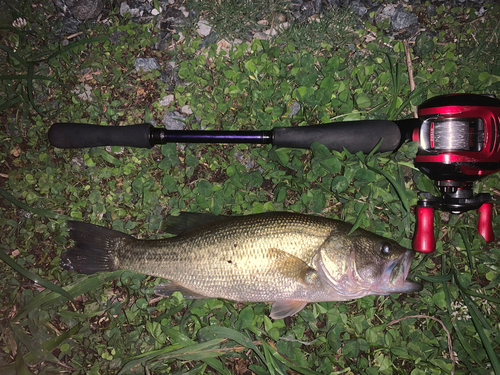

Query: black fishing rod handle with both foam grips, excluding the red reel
[49,120,412,153]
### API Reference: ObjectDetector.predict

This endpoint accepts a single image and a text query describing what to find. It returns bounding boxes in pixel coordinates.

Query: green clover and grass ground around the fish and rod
[0,1,500,375]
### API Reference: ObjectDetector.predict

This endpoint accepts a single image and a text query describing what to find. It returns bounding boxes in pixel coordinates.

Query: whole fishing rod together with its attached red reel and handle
[48,94,500,253]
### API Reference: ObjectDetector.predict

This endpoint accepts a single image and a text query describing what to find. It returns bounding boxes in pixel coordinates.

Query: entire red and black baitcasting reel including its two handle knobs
[412,94,500,252]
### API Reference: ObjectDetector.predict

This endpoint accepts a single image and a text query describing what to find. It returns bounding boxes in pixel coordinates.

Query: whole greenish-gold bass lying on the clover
[60,212,422,319]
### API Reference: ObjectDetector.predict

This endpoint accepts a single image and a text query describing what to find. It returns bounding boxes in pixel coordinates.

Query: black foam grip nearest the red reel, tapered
[273,120,401,154]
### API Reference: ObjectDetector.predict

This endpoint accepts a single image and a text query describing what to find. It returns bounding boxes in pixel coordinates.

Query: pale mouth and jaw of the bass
[372,250,423,294]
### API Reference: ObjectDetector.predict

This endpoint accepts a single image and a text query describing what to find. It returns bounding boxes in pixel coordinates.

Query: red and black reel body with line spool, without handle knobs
[413,94,500,182]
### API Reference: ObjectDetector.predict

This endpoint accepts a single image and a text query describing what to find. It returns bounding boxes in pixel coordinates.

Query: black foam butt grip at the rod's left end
[49,123,152,148]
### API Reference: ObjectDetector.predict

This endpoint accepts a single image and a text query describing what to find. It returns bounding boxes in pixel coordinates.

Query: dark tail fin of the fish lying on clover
[60,221,133,274]
